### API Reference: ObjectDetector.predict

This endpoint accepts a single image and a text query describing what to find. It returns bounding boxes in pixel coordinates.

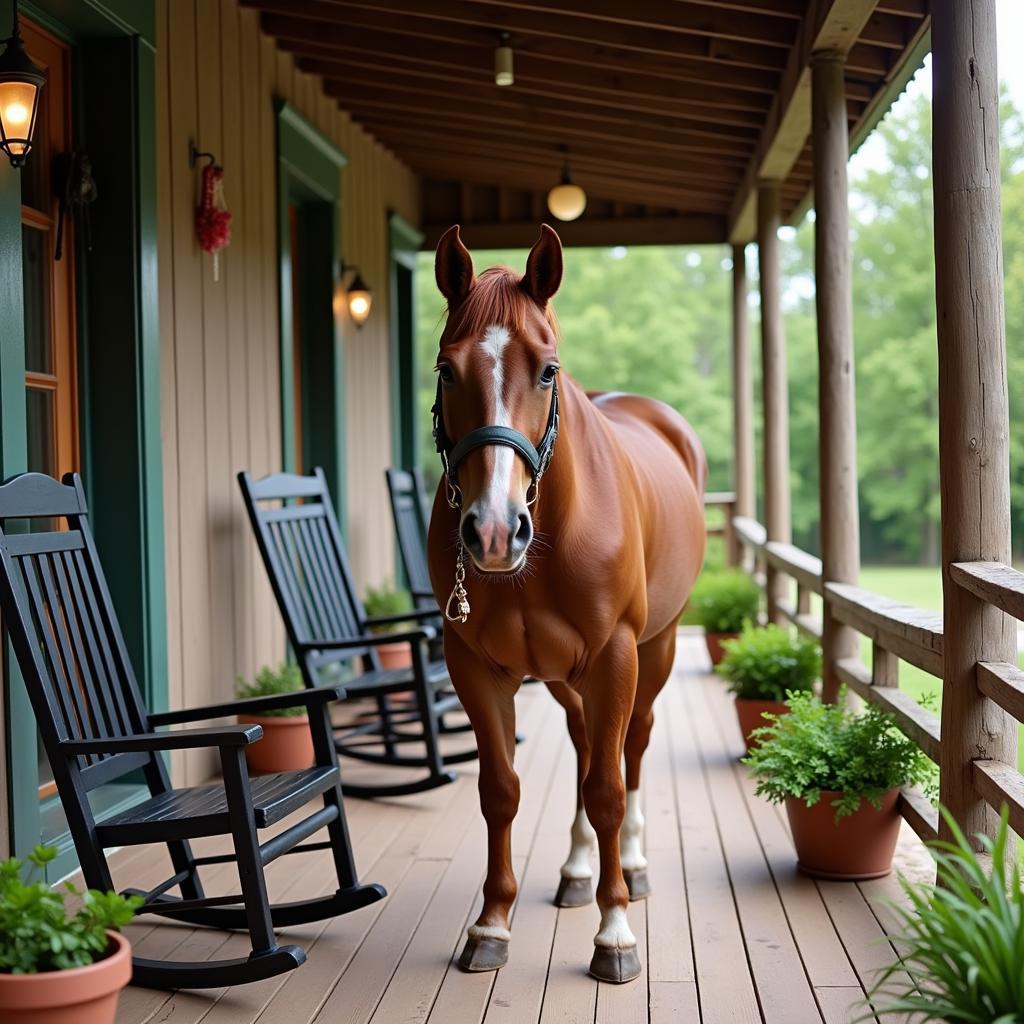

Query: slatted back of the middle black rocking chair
[239,468,380,686]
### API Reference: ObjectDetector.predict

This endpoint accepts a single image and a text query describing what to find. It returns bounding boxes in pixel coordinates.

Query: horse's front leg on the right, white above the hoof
[580,630,640,982]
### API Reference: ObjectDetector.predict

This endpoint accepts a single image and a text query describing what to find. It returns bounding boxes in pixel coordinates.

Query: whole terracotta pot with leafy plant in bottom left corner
[0,846,142,1024]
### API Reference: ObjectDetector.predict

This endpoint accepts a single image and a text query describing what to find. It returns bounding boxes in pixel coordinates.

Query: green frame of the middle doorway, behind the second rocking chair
[274,99,348,528]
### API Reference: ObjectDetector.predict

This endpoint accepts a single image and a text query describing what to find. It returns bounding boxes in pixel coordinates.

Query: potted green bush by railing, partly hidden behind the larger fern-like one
[718,623,821,750]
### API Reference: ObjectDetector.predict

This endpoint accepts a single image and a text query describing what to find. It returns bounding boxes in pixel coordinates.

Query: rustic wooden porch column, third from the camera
[758,181,792,624]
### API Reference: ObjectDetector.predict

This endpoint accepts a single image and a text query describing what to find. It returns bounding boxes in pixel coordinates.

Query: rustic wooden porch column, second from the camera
[811,53,860,700]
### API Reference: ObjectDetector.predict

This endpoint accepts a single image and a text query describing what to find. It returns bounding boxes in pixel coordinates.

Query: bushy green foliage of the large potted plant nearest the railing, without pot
[743,689,934,821]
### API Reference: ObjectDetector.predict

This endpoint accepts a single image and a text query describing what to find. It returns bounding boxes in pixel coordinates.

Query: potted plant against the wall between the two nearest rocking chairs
[234,663,313,774]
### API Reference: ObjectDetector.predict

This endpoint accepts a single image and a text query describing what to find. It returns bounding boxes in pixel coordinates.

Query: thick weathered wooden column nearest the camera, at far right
[932,0,1017,838]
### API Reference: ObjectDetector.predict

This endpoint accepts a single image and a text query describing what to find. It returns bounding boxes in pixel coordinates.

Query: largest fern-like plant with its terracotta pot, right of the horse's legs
[744,690,933,881]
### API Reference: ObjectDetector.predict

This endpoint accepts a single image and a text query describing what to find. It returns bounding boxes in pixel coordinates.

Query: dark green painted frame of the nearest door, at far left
[0,0,167,874]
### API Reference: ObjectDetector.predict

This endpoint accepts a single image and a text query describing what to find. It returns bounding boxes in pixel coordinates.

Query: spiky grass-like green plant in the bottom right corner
[860,808,1024,1024]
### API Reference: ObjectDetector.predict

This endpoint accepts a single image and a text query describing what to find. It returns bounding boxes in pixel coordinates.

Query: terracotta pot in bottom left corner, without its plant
[0,932,131,1024]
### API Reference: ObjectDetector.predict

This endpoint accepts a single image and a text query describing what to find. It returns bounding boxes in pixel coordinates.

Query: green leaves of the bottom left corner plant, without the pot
[0,846,142,974]
